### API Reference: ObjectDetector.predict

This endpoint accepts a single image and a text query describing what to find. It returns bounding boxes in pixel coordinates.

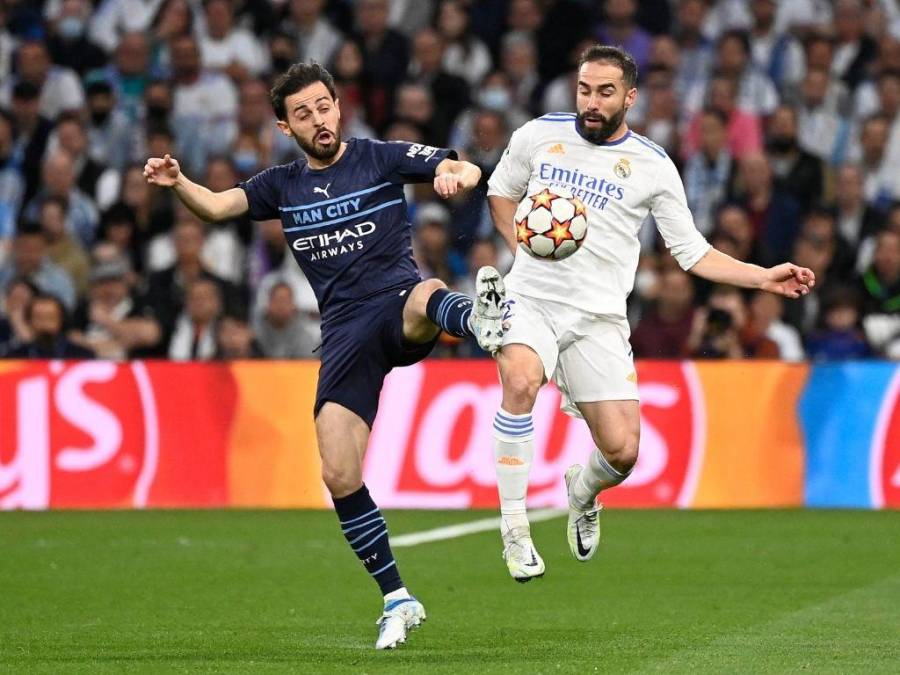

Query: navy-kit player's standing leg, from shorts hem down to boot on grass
[316,401,425,649]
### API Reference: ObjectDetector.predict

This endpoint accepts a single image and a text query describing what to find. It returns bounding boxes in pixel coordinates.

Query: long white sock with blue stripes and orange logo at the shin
[494,408,534,532]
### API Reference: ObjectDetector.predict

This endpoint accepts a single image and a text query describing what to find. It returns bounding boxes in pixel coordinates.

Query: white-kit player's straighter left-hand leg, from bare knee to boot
[494,344,544,582]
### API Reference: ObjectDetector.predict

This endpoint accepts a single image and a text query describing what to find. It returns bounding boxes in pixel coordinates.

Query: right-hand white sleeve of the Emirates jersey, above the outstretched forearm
[650,157,710,270]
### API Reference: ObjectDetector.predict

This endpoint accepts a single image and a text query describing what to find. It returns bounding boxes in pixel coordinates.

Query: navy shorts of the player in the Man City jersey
[314,286,438,427]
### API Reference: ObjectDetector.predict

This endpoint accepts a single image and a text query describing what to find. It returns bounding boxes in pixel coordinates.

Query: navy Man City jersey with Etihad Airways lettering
[238,138,456,322]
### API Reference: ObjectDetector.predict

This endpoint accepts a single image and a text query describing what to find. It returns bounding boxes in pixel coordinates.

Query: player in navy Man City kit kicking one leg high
[144,64,504,649]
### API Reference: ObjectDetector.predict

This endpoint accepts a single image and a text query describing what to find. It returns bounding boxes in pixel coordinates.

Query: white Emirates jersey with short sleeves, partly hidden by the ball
[488,113,710,317]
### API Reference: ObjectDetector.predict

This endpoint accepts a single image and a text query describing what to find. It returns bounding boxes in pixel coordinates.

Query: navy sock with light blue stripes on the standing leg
[334,485,403,595]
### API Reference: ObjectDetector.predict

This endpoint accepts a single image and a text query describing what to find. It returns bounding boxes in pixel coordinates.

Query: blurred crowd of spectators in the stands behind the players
[0,0,900,360]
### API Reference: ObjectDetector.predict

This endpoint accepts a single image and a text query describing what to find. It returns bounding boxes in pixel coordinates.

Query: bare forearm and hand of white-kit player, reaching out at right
[690,248,816,298]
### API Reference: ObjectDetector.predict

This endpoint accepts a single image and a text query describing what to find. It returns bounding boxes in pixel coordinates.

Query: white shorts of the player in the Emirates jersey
[503,292,639,417]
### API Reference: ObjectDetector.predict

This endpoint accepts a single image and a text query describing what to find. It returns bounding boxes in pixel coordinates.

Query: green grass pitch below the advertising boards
[0,510,900,675]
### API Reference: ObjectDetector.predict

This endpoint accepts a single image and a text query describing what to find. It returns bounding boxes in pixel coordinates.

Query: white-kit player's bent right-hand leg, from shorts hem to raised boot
[565,401,641,562]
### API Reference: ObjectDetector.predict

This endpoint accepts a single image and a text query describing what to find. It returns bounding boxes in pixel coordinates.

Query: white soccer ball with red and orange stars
[514,188,587,260]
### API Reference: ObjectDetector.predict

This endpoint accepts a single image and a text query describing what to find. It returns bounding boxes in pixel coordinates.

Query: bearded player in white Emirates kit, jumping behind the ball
[488,45,815,582]
